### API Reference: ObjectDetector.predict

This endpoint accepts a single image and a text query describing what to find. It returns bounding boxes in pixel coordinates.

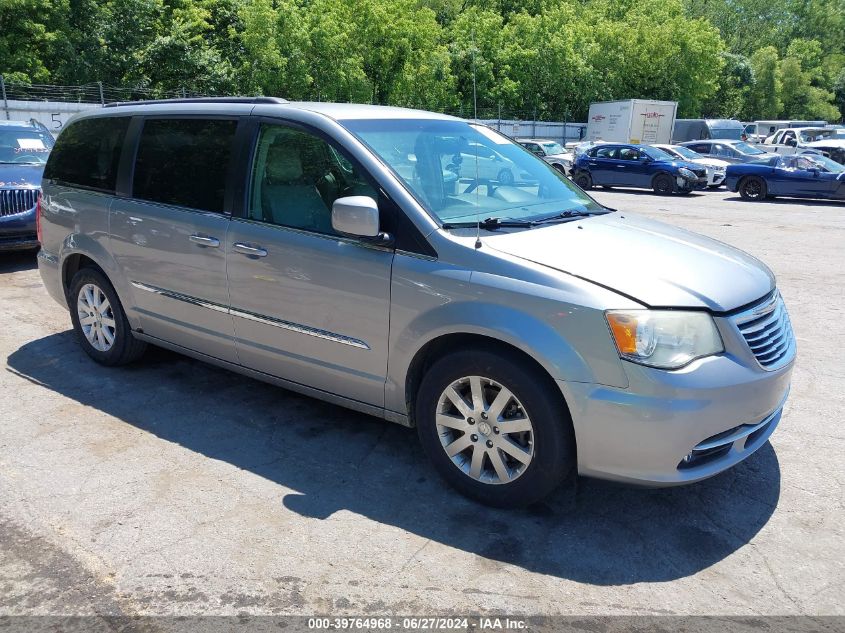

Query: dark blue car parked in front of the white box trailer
[572,143,707,194]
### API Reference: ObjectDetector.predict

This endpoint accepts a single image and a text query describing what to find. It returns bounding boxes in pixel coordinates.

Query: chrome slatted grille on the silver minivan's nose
[734,290,795,370]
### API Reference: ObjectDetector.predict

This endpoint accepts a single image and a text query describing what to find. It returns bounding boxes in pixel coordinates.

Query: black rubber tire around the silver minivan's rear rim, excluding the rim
[68,268,147,367]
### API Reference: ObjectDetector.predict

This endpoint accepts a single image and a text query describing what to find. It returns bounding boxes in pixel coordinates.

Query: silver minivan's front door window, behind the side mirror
[248,124,378,235]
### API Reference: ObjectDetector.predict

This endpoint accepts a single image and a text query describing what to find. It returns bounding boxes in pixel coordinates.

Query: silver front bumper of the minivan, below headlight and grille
[559,352,793,486]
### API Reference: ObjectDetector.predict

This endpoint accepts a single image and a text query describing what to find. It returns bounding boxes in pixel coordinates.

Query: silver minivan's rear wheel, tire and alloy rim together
[68,268,147,366]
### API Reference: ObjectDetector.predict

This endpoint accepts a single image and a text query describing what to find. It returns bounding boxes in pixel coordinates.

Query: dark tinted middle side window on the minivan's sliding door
[132,119,238,213]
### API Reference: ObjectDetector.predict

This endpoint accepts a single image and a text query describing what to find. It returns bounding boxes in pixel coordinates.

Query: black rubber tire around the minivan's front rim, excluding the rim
[415,349,575,508]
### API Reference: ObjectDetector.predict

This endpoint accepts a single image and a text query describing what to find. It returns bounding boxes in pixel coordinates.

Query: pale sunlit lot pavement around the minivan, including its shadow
[0,190,845,615]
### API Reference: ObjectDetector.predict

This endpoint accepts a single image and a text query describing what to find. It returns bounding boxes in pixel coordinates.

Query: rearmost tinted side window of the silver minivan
[44,117,129,193]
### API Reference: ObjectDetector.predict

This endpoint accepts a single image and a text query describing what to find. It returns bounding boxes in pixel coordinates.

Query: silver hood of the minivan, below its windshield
[484,212,775,312]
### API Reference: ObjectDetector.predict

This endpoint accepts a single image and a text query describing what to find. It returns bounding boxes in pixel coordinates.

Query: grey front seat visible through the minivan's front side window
[261,139,334,233]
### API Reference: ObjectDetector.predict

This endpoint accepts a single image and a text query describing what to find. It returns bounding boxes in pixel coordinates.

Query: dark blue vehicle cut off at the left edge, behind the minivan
[0,120,53,251]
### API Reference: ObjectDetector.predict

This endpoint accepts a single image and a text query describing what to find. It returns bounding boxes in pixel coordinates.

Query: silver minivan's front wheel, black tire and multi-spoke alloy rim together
[415,350,575,507]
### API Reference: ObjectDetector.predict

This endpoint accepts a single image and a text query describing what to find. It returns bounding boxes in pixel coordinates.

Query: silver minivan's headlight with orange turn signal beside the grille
[605,310,724,369]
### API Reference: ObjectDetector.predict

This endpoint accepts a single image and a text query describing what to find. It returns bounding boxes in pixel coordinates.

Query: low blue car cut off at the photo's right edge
[725,154,845,200]
